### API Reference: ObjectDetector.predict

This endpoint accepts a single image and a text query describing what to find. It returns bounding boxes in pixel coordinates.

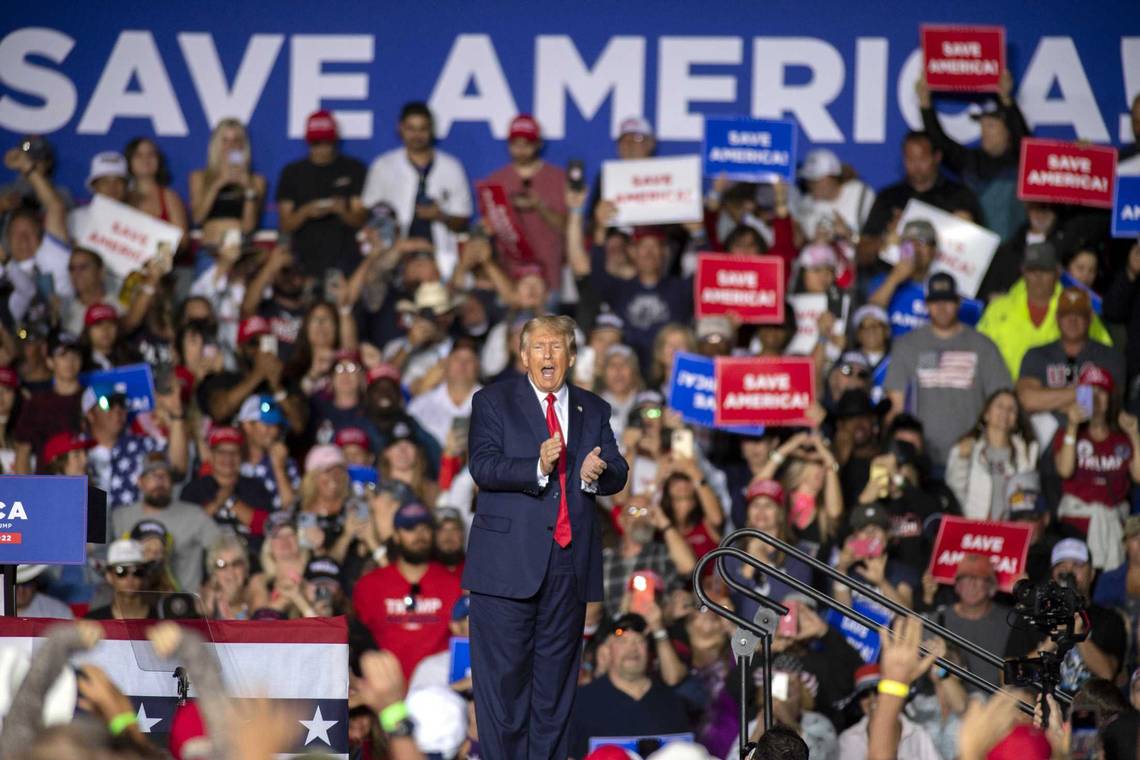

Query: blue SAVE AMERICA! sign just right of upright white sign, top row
[703,117,796,182]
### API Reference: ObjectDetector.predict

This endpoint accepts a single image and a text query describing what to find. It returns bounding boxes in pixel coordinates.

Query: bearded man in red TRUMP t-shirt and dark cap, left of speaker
[352,502,463,678]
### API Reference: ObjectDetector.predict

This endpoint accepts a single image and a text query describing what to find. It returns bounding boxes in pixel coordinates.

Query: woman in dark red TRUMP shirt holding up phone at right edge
[1053,365,1140,570]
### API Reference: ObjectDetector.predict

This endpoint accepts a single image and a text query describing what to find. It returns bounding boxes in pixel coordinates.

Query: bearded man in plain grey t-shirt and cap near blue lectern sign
[111,452,219,594]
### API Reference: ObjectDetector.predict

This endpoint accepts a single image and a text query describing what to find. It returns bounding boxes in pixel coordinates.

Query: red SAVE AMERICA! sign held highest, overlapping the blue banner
[919,24,1005,92]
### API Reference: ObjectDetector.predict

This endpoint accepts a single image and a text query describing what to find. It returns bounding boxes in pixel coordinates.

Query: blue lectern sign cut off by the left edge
[0,475,87,565]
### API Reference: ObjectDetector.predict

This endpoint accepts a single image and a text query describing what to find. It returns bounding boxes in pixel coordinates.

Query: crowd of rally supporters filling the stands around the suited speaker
[0,66,1140,760]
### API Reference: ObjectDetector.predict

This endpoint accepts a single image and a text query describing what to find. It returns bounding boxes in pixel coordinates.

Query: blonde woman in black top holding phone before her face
[190,119,267,246]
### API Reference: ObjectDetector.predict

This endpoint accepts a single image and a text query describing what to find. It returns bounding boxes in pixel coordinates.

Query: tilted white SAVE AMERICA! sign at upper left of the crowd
[76,195,182,277]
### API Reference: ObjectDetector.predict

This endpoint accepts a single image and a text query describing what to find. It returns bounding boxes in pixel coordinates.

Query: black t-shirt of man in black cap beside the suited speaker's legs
[570,677,689,760]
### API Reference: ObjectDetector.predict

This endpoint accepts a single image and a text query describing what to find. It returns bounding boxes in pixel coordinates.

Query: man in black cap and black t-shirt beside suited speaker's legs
[570,613,690,758]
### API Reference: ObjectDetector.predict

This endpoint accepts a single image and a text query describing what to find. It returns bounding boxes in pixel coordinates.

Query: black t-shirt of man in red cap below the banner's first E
[277,155,367,277]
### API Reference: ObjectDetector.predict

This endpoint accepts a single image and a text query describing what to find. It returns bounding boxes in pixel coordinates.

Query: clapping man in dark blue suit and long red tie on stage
[463,317,628,760]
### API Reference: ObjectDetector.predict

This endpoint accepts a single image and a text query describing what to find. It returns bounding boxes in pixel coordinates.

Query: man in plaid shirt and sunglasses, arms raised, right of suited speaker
[602,493,697,615]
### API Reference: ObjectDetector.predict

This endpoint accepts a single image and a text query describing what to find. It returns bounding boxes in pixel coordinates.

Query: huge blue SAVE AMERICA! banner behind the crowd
[0,0,1140,223]
